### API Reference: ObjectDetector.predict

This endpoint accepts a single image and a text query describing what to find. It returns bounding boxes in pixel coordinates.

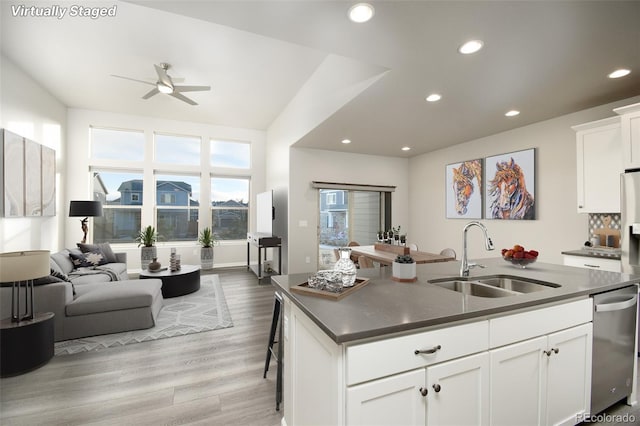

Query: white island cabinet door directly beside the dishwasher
[544,323,593,425]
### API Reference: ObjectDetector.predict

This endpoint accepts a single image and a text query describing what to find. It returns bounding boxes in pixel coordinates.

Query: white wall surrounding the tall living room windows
[64,109,265,270]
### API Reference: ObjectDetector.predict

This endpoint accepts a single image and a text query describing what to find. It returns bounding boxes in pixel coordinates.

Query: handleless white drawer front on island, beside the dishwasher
[489,298,593,348]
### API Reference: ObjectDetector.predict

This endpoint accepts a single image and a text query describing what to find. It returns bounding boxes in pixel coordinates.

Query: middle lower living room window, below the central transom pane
[156,175,200,241]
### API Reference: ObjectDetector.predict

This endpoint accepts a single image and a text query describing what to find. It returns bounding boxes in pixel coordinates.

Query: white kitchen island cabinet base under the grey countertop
[284,298,593,426]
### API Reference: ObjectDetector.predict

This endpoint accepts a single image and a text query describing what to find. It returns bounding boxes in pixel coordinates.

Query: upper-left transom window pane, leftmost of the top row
[90,127,144,161]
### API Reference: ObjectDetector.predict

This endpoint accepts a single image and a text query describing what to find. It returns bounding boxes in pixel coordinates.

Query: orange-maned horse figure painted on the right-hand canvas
[487,157,535,219]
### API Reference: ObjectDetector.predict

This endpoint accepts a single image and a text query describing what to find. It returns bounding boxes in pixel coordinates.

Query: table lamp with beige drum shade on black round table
[0,250,50,322]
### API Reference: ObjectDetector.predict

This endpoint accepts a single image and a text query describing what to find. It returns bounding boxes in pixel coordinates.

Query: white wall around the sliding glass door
[288,148,408,274]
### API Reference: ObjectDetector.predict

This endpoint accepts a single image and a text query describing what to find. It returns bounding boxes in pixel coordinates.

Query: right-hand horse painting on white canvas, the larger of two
[484,148,536,220]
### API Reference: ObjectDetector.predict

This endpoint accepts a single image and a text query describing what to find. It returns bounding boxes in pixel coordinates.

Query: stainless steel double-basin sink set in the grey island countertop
[428,275,560,297]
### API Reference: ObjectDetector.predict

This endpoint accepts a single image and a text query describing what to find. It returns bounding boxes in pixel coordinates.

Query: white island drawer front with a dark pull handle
[346,321,489,385]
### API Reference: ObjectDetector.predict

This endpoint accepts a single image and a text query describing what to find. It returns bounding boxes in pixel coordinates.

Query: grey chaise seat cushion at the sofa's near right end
[66,279,162,316]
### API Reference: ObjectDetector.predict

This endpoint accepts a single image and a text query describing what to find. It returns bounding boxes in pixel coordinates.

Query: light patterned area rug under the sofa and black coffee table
[55,275,233,355]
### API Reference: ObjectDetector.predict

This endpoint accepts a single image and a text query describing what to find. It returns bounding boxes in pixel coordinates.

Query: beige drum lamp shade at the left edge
[0,250,50,283]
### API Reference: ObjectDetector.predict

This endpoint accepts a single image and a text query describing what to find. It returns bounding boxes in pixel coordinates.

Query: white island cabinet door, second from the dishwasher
[490,336,547,426]
